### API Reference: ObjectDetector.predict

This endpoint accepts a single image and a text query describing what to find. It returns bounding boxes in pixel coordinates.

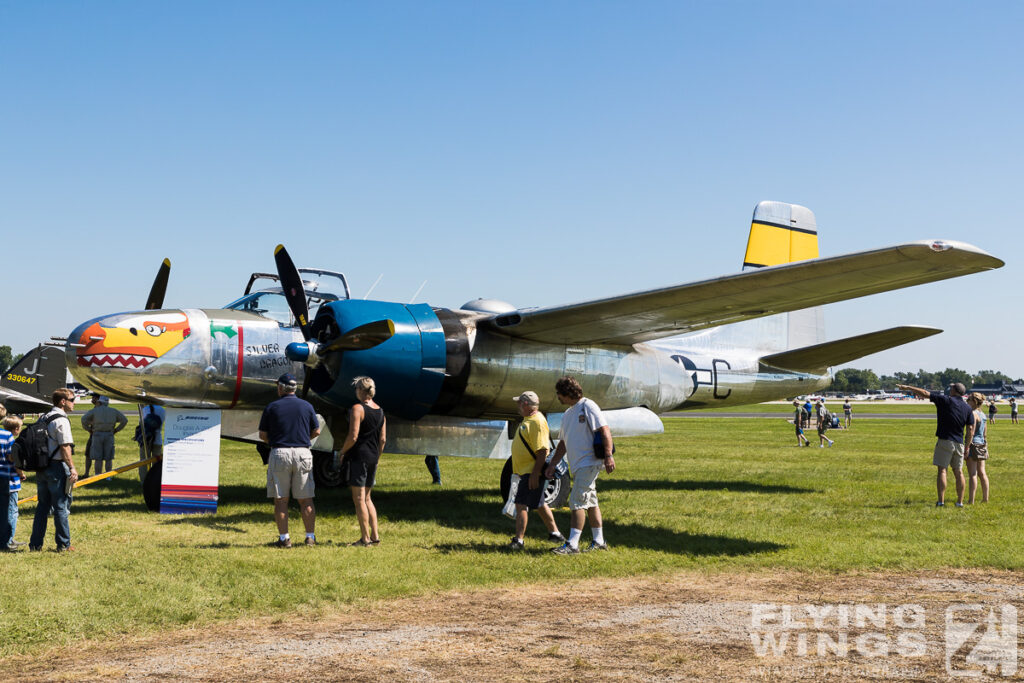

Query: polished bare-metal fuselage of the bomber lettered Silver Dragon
[68,309,829,420]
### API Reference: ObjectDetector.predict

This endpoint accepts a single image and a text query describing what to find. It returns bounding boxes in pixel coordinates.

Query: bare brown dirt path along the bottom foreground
[8,570,1024,681]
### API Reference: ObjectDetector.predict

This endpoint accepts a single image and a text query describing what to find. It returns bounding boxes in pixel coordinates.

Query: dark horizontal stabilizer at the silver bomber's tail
[761,325,942,374]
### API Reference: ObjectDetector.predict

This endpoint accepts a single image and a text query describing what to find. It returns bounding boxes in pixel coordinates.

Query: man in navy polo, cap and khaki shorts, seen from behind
[259,373,319,548]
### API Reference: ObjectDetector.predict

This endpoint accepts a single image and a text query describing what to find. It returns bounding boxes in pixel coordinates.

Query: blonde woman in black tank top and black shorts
[341,377,386,546]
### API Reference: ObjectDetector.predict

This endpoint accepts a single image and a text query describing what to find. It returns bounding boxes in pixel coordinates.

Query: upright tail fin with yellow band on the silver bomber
[675,202,825,352]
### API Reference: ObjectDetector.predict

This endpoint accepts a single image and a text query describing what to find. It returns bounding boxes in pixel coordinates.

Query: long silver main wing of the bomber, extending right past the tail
[482,241,1002,344]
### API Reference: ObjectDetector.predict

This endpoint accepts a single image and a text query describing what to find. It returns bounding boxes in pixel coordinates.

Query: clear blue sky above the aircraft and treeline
[0,0,1024,377]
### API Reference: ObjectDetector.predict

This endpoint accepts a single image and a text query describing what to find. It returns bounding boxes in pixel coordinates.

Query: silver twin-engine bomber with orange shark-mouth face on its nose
[67,202,1002,497]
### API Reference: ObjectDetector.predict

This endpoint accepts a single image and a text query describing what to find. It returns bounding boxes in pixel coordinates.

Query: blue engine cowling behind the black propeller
[310,299,445,420]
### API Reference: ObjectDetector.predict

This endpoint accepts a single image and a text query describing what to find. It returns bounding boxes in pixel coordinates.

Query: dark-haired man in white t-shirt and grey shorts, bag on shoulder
[545,377,615,555]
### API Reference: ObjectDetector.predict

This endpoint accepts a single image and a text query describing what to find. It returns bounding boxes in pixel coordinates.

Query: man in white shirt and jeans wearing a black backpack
[29,388,78,553]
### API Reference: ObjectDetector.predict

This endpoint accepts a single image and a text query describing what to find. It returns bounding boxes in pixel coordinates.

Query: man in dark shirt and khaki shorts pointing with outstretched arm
[896,382,974,508]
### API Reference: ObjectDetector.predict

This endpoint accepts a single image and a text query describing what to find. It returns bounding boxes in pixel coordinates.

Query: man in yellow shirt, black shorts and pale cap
[508,391,565,552]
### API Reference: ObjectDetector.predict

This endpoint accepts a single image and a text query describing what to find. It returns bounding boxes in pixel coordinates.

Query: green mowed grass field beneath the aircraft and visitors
[0,411,1024,656]
